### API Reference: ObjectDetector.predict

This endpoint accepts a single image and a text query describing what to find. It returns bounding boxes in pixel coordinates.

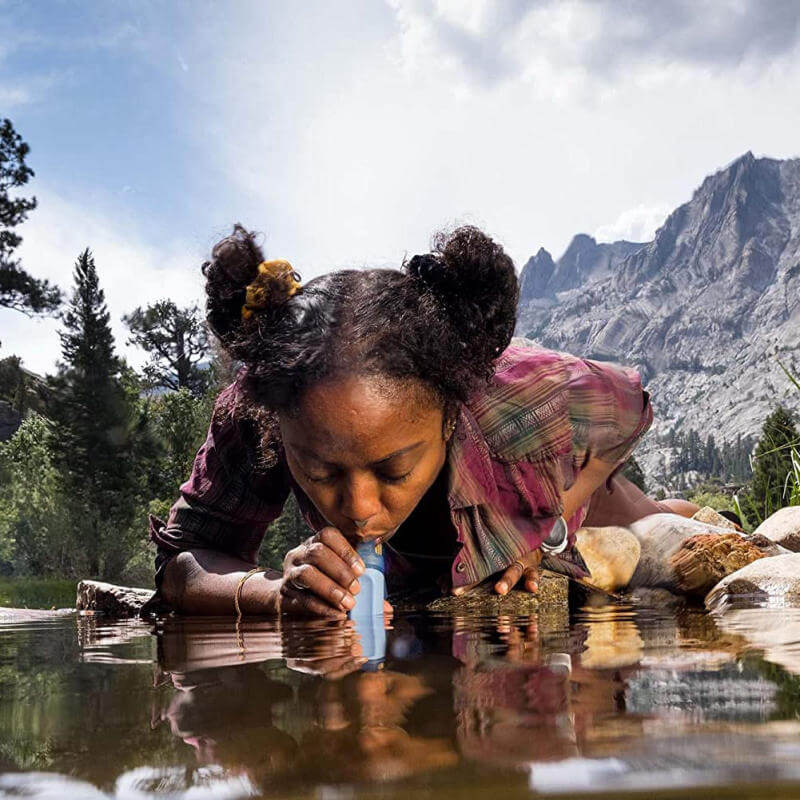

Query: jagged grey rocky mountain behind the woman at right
[517,152,800,484]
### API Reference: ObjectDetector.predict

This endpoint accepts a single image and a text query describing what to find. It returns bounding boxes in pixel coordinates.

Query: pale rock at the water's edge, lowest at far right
[706,553,800,610]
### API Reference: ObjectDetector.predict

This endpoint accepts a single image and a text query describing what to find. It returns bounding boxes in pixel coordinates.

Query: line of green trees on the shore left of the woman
[0,120,307,583]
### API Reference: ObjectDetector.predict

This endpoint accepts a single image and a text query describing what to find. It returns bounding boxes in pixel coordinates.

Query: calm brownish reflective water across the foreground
[0,606,800,800]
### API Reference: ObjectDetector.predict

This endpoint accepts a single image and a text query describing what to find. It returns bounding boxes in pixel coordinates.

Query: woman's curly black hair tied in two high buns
[203,224,519,462]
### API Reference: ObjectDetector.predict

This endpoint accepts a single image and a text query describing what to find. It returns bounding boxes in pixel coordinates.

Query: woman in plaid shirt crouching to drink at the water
[151,225,692,617]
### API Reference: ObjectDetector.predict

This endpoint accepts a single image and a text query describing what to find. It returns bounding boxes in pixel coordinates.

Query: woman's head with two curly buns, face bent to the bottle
[203,226,518,536]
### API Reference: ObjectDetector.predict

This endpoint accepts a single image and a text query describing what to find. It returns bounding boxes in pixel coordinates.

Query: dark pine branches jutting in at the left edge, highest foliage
[0,119,61,314]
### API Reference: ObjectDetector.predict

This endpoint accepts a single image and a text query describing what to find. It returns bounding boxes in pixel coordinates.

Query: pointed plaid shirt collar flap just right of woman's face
[447,403,499,508]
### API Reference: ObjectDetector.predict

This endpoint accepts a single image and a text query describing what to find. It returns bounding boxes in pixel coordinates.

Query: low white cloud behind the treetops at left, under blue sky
[0,186,206,373]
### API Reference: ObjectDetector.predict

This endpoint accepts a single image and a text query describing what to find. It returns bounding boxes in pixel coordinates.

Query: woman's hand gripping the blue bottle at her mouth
[279,526,364,619]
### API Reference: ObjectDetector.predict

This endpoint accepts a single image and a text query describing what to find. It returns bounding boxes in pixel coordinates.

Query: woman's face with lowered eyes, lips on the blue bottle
[280,376,447,541]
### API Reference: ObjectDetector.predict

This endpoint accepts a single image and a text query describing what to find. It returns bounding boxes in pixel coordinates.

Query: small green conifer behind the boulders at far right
[740,405,800,521]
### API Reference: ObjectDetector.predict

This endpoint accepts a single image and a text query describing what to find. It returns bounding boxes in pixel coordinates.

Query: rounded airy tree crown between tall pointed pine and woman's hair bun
[122,300,209,397]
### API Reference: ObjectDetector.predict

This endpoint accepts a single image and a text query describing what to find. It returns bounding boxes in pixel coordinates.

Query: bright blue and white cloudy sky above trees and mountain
[0,0,800,373]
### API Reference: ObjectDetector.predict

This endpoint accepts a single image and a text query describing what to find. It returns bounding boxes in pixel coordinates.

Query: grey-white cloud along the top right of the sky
[387,0,800,97]
